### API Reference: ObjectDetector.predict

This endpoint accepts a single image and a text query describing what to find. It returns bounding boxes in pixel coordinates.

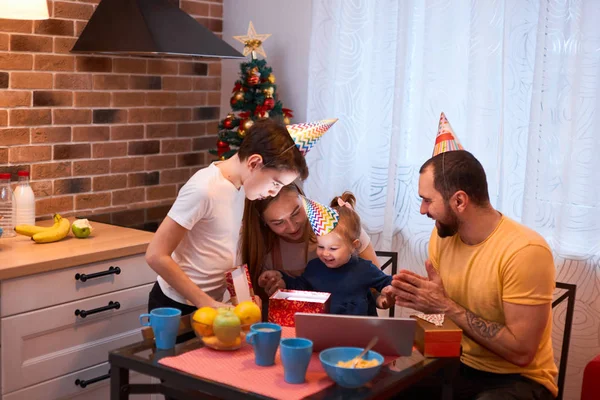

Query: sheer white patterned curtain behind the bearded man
[305,0,600,399]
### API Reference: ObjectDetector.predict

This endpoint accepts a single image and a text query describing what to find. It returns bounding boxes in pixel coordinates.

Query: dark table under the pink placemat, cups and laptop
[109,338,459,400]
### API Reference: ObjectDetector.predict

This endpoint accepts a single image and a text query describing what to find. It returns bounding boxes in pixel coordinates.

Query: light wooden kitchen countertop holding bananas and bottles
[0,218,154,280]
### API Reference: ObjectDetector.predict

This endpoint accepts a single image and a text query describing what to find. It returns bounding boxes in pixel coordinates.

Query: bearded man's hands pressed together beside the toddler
[384,260,453,314]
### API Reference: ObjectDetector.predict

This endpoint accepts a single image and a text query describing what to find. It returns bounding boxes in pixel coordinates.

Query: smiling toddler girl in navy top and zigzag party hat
[258,192,393,315]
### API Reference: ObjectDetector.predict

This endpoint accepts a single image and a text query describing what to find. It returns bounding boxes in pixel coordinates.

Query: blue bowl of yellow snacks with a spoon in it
[319,347,383,388]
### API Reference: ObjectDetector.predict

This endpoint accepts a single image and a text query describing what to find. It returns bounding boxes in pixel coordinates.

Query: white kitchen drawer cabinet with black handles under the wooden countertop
[0,254,156,400]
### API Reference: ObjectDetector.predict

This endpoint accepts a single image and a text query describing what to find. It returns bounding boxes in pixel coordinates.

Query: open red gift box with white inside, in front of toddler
[269,289,331,327]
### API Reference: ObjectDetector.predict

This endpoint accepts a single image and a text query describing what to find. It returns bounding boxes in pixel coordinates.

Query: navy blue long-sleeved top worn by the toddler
[282,257,392,315]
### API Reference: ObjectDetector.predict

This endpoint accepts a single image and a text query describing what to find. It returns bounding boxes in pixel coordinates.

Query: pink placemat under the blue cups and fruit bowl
[159,327,332,400]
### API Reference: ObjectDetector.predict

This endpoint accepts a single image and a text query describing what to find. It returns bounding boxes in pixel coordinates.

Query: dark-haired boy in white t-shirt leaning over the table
[146,120,331,314]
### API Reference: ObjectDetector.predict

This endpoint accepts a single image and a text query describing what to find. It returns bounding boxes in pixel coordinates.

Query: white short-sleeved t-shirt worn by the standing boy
[157,163,245,304]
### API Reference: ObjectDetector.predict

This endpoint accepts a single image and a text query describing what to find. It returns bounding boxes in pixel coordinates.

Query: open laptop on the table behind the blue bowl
[295,313,417,356]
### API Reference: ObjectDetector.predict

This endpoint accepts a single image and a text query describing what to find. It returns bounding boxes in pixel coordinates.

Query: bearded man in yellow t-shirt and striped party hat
[387,113,558,400]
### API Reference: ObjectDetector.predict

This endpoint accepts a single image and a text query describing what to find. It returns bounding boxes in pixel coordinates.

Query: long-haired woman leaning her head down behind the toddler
[241,183,384,315]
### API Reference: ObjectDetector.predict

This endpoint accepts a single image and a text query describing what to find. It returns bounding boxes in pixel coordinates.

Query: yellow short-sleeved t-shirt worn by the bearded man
[429,216,558,396]
